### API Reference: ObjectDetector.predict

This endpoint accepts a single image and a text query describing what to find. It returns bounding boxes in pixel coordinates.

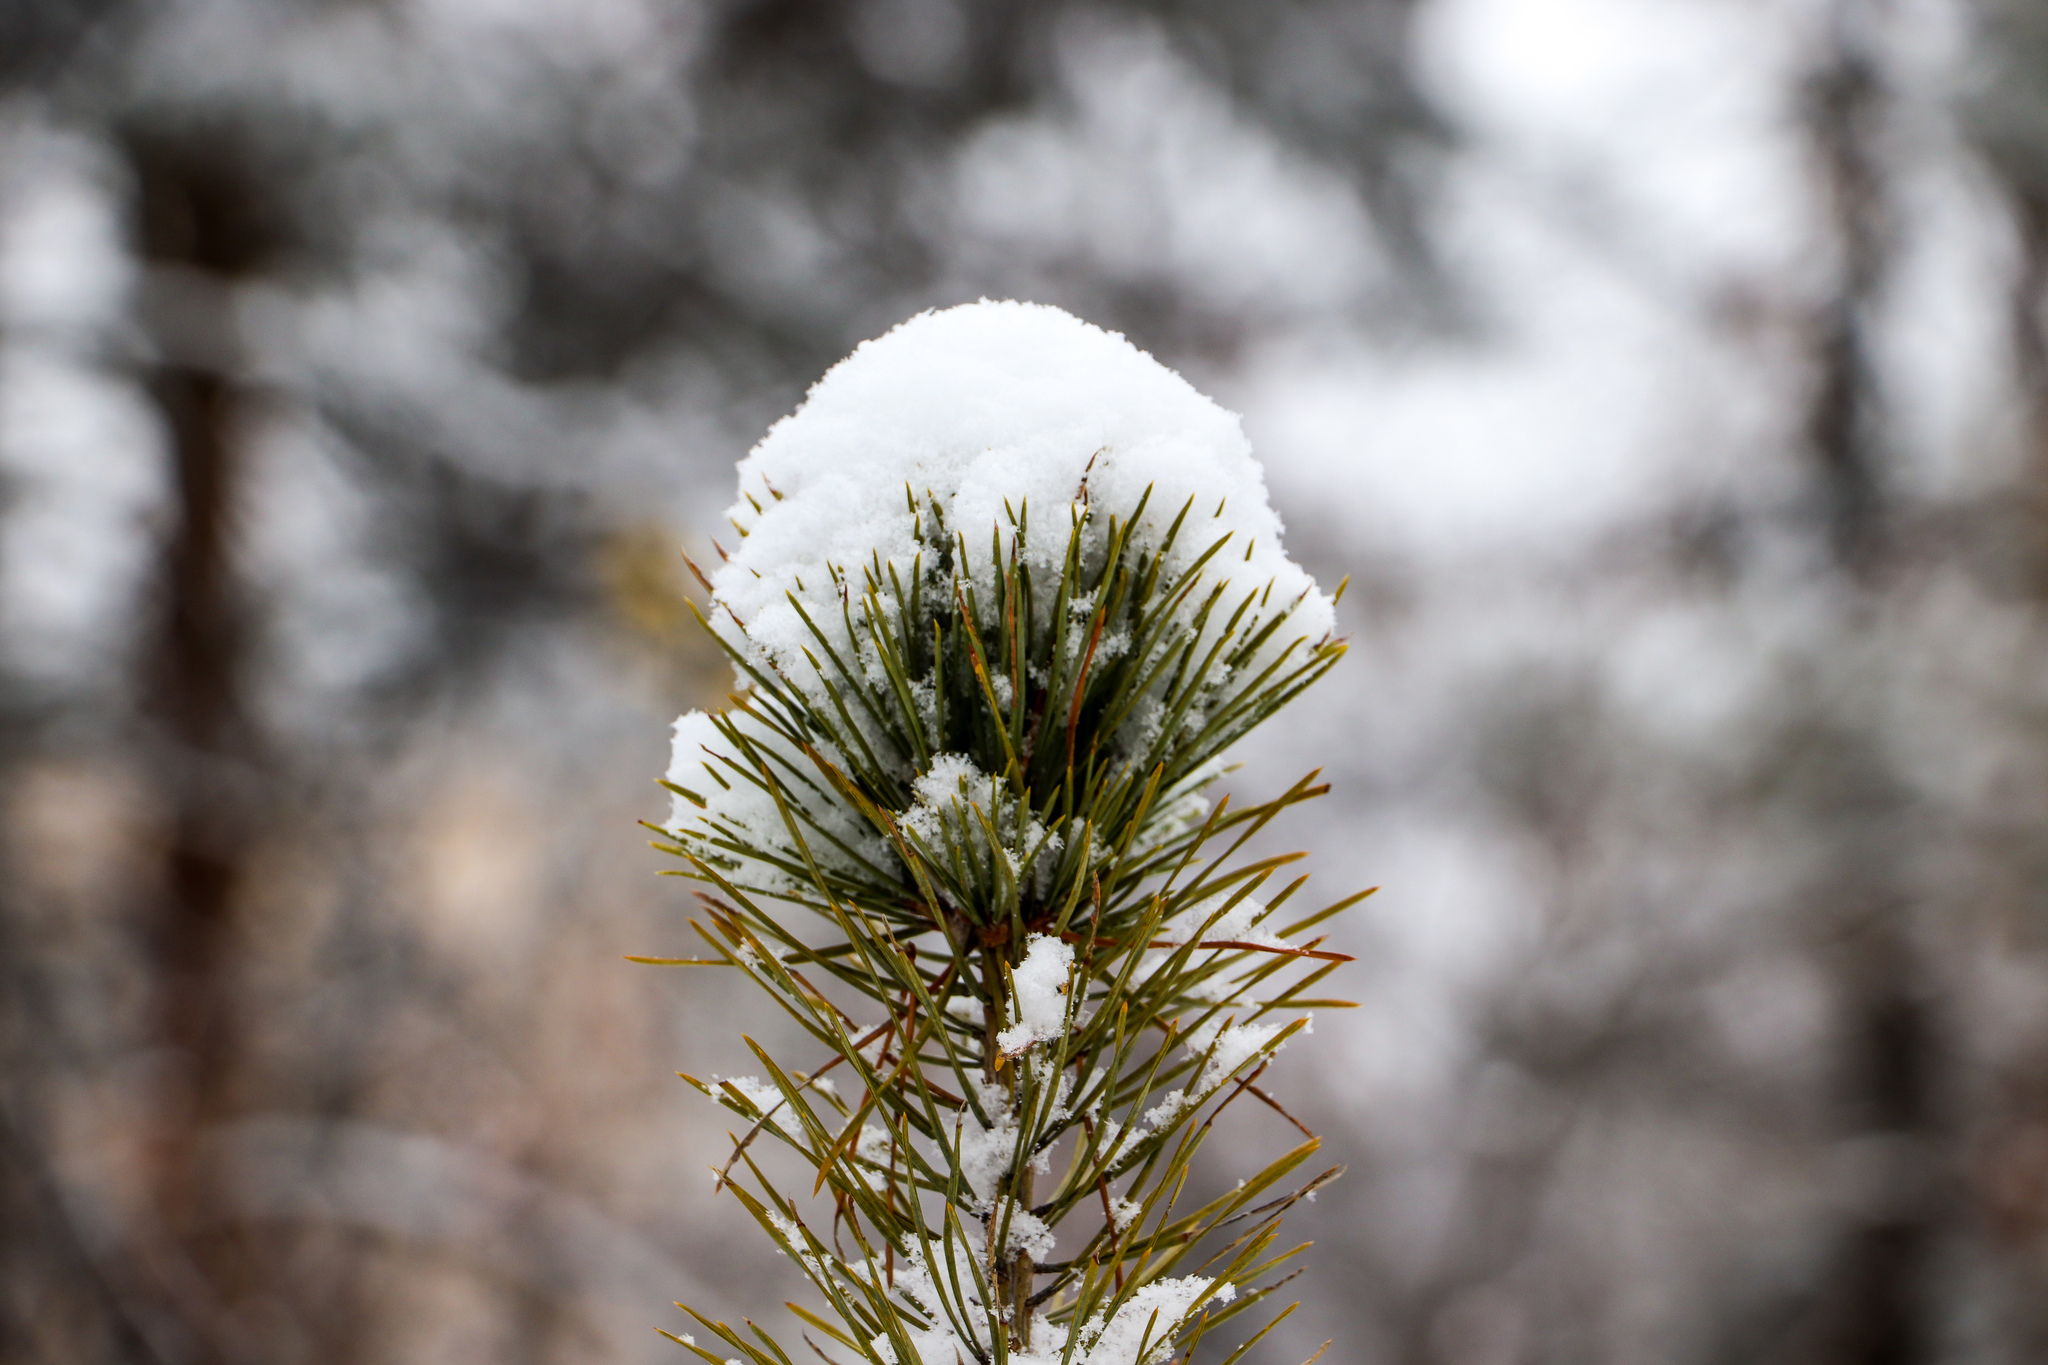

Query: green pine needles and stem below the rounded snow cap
[641,495,1366,1365]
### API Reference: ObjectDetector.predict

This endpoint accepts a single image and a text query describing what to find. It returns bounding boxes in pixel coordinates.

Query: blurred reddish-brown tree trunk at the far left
[131,127,274,1365]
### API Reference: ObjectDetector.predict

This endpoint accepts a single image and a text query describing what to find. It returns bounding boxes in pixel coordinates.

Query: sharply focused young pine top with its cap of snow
[662,301,1358,1365]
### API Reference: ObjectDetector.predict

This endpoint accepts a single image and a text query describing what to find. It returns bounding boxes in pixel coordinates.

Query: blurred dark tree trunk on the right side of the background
[1806,10,1942,1365]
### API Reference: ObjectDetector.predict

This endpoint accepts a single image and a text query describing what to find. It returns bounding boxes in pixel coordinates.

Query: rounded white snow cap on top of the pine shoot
[713,301,1333,679]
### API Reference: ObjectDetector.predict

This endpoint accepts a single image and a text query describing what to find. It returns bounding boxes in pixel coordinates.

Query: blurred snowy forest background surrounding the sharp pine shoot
[0,0,2048,1365]
